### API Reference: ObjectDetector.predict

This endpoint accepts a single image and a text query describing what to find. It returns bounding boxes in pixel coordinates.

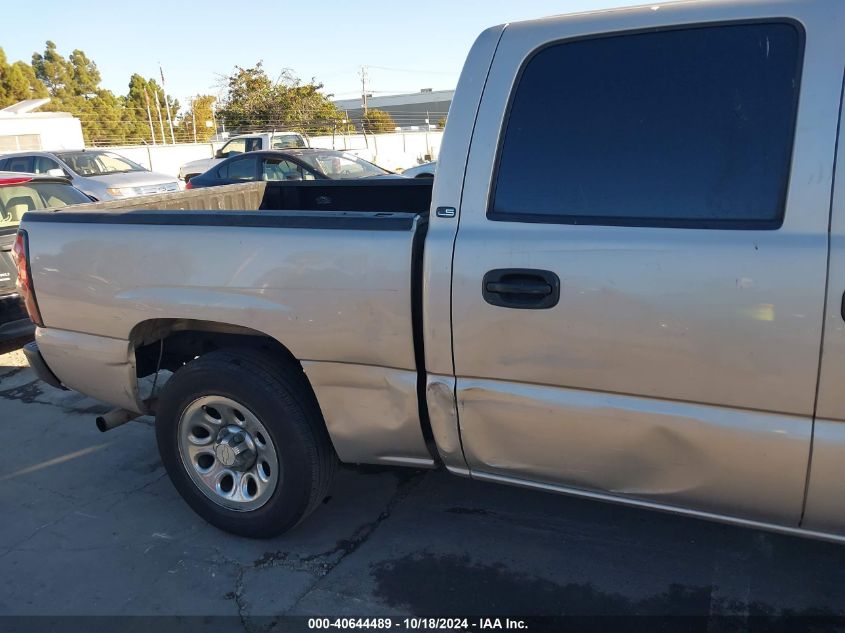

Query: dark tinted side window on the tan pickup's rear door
[489,23,801,228]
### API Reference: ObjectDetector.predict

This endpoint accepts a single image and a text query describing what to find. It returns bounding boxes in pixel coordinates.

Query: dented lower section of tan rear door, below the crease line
[458,379,811,525]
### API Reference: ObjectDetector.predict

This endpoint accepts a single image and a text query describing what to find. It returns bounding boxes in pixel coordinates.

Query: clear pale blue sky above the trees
[0,0,644,110]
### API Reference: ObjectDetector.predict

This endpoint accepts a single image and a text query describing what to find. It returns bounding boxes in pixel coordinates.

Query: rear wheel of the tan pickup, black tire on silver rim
[156,349,337,538]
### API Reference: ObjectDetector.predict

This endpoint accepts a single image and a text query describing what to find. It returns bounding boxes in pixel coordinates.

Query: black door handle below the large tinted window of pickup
[481,268,560,310]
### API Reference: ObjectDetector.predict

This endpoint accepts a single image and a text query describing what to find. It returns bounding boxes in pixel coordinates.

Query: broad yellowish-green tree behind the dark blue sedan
[218,62,344,134]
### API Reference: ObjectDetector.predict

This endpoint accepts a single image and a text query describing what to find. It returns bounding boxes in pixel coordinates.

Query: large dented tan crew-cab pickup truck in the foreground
[11,0,845,540]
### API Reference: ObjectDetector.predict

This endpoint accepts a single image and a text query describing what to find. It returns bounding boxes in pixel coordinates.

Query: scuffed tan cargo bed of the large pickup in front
[24,179,432,465]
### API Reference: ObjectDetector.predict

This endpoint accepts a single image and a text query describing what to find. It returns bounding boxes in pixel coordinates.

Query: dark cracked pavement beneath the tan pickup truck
[0,338,845,630]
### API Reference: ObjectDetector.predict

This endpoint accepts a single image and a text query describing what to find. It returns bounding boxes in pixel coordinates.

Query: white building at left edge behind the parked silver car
[0,99,85,153]
